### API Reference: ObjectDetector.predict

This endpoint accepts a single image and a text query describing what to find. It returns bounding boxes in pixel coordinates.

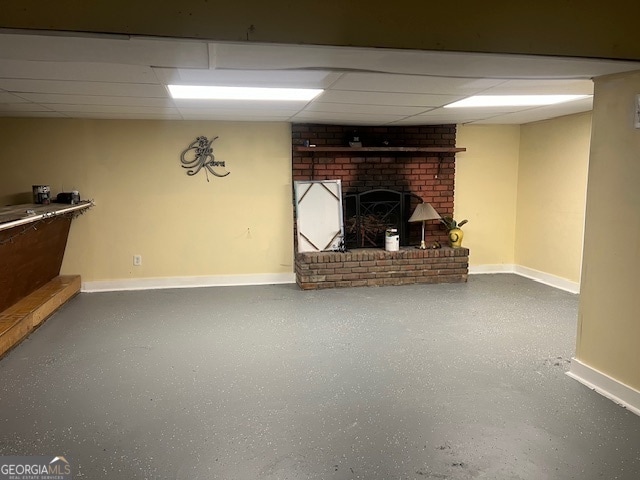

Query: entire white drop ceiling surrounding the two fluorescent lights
[0,30,640,125]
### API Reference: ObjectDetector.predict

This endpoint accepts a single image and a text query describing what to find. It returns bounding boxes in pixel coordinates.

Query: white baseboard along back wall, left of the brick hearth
[81,273,296,292]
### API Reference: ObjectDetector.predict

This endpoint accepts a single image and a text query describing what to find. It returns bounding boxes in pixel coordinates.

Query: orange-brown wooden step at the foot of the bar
[0,275,80,358]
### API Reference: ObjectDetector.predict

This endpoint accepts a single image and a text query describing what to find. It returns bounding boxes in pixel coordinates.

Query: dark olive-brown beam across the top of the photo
[0,0,640,59]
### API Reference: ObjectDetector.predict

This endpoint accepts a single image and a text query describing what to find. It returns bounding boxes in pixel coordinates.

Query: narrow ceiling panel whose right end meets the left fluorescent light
[0,79,168,97]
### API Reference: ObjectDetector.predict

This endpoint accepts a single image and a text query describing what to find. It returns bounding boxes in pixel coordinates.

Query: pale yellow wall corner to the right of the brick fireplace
[455,113,591,283]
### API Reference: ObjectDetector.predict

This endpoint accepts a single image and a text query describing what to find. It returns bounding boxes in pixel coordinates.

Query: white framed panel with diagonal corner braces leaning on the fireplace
[294,180,344,252]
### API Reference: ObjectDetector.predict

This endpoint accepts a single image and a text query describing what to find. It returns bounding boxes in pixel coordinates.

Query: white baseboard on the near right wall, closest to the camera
[567,358,640,415]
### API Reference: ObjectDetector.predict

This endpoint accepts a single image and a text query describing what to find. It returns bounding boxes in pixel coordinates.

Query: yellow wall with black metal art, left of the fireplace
[0,119,293,281]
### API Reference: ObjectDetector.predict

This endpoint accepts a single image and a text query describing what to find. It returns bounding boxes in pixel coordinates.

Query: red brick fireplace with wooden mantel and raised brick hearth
[292,124,468,289]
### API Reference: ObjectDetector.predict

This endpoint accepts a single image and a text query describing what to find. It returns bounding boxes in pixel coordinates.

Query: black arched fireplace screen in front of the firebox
[343,189,422,248]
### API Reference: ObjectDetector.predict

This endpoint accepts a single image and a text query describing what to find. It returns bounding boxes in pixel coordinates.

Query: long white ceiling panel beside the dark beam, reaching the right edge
[214,42,638,79]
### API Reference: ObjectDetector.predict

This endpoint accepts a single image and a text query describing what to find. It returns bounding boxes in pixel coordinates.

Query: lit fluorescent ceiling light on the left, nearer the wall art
[167,85,323,102]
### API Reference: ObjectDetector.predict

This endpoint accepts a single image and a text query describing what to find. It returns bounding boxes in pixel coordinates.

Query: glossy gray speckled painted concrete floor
[0,275,640,480]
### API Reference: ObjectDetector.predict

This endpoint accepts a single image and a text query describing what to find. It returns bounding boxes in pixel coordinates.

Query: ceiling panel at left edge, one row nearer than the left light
[0,60,158,83]
